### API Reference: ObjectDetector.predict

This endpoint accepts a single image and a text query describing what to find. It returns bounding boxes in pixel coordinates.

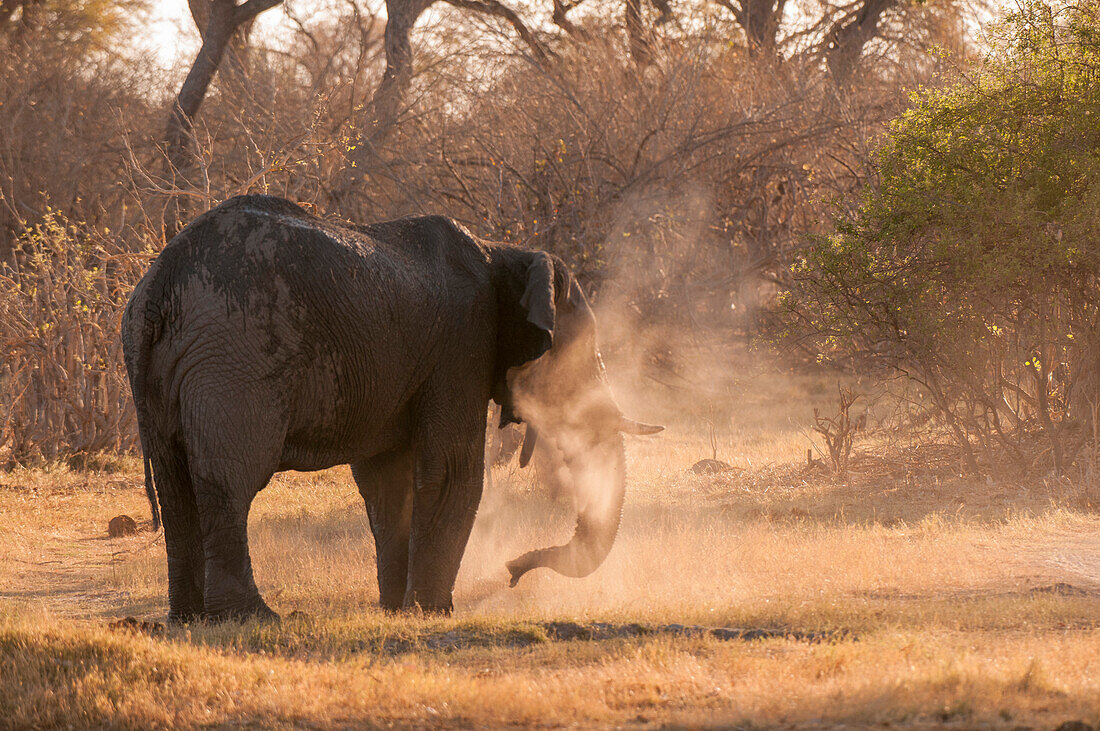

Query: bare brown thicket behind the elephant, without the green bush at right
[0,0,965,464]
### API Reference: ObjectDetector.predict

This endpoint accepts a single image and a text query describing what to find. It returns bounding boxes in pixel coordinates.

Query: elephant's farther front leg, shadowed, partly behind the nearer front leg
[351,448,415,611]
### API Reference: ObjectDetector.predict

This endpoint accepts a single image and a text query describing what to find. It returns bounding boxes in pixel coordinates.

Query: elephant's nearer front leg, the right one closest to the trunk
[404,433,484,613]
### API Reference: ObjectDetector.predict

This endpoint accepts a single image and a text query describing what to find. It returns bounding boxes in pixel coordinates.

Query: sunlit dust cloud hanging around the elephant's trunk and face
[455,195,804,621]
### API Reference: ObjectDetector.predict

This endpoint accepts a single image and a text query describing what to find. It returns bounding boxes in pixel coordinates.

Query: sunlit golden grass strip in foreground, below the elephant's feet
[0,607,1100,727]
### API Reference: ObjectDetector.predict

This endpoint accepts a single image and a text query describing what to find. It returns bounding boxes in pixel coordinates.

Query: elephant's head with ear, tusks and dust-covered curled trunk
[494,251,662,586]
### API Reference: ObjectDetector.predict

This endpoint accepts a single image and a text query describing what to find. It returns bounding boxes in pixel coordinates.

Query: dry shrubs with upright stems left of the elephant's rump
[0,211,144,466]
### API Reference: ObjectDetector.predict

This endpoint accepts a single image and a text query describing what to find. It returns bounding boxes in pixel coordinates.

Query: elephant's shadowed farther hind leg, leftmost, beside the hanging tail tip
[151,441,206,623]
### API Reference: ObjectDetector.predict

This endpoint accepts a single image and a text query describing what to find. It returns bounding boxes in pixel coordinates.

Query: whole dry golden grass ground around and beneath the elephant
[0,379,1100,728]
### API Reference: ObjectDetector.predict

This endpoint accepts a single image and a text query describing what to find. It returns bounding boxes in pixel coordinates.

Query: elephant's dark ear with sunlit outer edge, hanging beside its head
[493,252,557,427]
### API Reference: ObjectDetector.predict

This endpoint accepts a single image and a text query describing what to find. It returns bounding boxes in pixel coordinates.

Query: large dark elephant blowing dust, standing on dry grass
[122,196,661,623]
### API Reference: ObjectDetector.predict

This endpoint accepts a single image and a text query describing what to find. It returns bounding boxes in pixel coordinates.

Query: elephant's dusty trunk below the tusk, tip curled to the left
[507,431,626,586]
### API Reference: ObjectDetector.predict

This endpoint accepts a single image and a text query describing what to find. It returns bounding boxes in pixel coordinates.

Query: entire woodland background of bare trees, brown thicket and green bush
[8,0,1100,490]
